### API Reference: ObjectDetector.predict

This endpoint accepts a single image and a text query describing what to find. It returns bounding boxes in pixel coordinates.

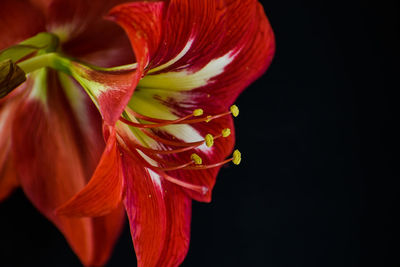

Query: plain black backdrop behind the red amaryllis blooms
[0,0,400,267]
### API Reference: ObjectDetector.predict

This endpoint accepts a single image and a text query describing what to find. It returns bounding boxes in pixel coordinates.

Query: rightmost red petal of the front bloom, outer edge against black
[200,0,275,106]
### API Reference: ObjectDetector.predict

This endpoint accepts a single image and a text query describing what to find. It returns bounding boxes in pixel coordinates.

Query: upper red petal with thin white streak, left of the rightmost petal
[148,0,226,72]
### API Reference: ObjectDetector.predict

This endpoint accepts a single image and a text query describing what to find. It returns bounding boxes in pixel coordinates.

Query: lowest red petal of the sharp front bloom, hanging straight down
[123,156,191,267]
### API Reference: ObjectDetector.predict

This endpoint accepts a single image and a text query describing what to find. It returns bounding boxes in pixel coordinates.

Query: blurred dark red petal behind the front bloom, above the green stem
[42,0,134,67]
